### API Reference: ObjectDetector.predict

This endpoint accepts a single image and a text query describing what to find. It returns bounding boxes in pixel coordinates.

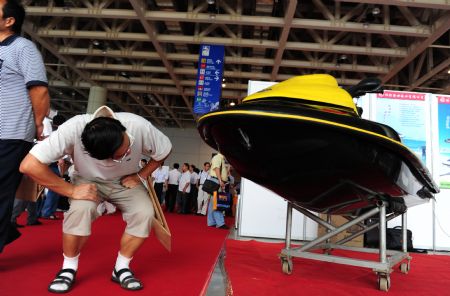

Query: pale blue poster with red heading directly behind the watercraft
[375,90,427,165]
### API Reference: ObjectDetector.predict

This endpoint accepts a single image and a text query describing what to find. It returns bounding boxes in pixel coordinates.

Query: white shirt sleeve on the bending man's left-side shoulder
[30,116,81,164]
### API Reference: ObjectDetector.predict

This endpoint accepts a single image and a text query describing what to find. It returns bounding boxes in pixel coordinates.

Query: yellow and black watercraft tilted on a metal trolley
[198,74,439,214]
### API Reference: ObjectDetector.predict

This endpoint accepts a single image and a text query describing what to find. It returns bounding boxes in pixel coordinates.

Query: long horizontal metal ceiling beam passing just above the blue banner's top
[38,29,407,58]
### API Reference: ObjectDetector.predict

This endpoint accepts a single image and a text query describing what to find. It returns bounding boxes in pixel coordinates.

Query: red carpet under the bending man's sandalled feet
[0,214,228,296]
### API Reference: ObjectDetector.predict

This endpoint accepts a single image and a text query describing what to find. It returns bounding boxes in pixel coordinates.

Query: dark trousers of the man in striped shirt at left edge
[0,140,31,253]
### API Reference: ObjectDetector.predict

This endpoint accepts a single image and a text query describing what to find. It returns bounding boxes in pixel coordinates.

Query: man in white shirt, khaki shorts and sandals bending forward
[20,106,172,293]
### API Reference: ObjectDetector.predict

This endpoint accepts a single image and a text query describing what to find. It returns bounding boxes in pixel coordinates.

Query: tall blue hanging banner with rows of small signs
[194,44,225,114]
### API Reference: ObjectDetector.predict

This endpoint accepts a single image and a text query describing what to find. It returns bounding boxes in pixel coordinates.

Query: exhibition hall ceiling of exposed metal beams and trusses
[24,0,450,127]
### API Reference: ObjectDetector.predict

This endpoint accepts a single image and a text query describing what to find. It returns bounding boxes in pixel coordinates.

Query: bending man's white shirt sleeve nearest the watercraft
[142,120,172,161]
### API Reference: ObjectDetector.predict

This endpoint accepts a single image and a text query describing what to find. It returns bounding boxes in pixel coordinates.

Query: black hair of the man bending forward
[81,117,126,160]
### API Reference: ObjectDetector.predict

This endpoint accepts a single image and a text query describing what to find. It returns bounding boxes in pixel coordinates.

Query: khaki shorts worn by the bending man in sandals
[63,176,155,238]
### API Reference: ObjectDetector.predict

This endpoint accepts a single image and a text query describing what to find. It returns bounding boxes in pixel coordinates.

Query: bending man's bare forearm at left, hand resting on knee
[20,153,97,201]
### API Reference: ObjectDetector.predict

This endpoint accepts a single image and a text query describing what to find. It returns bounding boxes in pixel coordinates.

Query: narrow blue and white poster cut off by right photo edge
[436,96,450,189]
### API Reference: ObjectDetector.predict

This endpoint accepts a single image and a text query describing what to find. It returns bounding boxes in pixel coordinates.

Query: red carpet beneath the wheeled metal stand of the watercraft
[225,240,450,296]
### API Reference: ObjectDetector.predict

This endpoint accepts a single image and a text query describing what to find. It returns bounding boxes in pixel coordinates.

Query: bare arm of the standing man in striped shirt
[28,85,50,140]
